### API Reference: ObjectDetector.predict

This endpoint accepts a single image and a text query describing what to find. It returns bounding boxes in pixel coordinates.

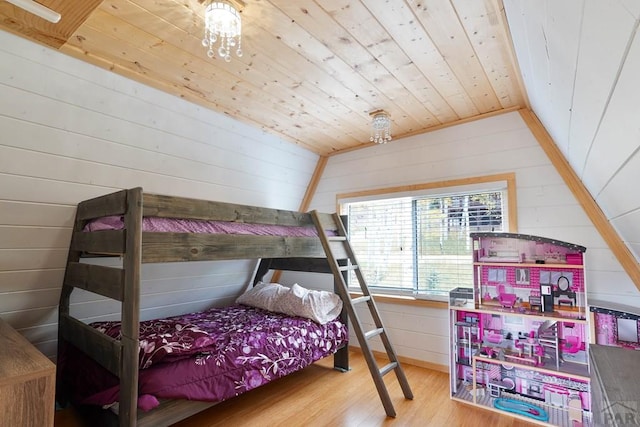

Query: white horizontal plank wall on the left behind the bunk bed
[0,32,318,357]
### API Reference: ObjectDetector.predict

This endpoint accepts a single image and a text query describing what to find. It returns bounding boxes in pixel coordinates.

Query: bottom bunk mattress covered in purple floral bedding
[58,304,348,410]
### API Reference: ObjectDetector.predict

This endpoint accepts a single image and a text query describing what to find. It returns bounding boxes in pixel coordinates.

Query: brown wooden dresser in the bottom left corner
[0,319,56,427]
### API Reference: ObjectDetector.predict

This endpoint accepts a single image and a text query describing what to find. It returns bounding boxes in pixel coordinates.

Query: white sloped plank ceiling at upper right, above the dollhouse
[504,0,640,296]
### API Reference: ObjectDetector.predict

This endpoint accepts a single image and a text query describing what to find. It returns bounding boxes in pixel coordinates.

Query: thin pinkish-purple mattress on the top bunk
[84,216,336,237]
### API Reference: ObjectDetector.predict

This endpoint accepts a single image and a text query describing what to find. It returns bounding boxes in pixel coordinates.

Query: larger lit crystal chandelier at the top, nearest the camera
[202,1,242,62]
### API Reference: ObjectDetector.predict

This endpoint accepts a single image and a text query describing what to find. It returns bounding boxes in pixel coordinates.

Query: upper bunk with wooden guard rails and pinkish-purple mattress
[71,187,344,262]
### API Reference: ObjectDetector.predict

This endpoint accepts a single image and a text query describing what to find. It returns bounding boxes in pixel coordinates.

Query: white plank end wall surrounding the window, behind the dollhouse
[282,113,640,365]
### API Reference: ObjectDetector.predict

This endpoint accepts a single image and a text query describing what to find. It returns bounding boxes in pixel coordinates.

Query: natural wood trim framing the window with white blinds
[336,173,517,301]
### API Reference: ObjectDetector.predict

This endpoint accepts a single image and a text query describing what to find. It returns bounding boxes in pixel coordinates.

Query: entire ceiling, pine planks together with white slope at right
[0,0,640,288]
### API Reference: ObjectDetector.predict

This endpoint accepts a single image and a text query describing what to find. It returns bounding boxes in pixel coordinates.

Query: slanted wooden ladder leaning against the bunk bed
[311,210,413,417]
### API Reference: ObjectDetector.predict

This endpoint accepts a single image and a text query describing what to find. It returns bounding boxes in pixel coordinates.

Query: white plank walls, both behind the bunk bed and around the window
[0,21,640,372]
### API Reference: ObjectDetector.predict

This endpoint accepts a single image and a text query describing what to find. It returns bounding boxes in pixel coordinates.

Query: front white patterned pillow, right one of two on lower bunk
[275,283,342,324]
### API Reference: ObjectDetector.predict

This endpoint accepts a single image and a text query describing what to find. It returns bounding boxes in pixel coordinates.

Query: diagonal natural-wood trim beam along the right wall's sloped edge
[520,109,640,290]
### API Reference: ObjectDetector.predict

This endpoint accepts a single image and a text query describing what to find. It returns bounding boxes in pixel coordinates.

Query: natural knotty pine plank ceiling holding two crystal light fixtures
[0,0,526,155]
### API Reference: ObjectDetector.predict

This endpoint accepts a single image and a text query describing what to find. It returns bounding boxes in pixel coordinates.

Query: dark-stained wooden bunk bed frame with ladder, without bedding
[58,188,412,426]
